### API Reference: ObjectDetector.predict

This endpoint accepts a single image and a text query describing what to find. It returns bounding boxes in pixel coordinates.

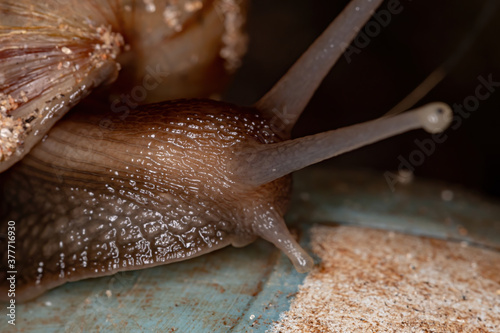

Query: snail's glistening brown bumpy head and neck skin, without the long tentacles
[0,100,298,300]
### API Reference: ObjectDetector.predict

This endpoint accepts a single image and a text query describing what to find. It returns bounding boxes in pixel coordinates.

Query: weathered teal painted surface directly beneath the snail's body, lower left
[0,233,305,332]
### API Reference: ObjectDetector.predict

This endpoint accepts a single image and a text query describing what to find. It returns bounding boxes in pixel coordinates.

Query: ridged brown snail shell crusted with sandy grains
[0,0,246,172]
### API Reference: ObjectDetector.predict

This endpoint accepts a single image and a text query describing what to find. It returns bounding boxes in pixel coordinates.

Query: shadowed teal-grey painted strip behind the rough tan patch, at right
[287,164,500,248]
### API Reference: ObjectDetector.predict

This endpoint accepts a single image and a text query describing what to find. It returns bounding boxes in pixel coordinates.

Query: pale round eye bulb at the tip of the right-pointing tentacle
[418,102,453,133]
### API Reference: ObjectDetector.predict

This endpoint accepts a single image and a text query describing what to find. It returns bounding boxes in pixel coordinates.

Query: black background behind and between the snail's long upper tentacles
[225,0,500,196]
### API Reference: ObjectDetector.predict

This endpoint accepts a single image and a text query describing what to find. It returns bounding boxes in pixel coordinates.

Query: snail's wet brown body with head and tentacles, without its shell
[0,0,451,299]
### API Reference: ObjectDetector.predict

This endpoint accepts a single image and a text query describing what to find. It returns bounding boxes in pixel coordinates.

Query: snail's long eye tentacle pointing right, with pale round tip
[234,102,453,185]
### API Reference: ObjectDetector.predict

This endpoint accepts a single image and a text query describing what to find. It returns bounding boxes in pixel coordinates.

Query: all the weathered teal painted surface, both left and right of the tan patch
[0,165,500,332]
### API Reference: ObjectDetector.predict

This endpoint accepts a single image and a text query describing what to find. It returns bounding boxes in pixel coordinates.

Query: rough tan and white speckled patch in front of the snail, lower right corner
[269,226,500,333]
